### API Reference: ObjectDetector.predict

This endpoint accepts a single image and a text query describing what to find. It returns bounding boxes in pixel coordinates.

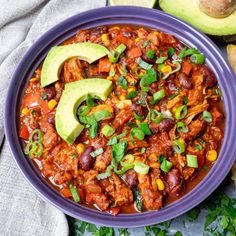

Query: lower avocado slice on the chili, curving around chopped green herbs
[55,78,113,144]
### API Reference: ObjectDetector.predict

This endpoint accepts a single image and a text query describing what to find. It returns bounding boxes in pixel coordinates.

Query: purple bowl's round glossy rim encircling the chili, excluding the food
[5,7,236,227]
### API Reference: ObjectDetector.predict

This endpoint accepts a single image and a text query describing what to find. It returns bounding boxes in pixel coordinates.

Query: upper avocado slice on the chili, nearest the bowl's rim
[41,42,109,87]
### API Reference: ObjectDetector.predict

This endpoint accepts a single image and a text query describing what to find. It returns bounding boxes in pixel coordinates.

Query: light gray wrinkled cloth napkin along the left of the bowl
[0,0,106,236]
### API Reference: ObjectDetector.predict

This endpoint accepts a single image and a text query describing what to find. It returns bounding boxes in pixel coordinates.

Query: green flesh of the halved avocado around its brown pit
[159,0,236,36]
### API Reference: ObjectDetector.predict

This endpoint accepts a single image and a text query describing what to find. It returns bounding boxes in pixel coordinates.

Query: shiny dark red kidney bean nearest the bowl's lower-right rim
[166,169,183,196]
